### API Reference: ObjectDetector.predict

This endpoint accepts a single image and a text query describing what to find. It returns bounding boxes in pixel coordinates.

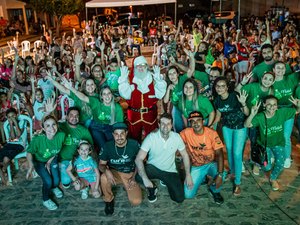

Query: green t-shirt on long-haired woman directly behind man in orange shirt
[177,95,214,118]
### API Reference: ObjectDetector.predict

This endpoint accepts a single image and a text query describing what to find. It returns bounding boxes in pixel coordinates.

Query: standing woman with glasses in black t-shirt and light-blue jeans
[213,77,249,196]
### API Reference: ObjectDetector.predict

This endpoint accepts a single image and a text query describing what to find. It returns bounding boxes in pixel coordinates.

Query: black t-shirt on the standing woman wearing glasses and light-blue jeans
[214,92,246,129]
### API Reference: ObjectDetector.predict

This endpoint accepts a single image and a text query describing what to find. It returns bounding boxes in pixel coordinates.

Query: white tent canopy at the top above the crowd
[85,0,176,8]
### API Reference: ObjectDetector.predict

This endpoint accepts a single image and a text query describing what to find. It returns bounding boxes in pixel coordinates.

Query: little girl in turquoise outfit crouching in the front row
[67,140,101,199]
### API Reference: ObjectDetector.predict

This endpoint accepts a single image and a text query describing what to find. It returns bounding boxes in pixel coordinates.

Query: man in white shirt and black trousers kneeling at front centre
[135,113,193,203]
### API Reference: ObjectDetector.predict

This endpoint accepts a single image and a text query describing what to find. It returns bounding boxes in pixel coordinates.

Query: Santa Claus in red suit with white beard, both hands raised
[118,56,167,142]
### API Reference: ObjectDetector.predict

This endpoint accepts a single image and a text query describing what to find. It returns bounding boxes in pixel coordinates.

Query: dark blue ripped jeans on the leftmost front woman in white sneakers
[33,157,59,201]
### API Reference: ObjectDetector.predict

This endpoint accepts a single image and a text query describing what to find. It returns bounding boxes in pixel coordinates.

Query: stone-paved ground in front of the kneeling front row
[0,138,300,225]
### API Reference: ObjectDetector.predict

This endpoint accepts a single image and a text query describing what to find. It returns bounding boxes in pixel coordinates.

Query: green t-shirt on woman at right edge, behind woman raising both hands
[273,73,299,106]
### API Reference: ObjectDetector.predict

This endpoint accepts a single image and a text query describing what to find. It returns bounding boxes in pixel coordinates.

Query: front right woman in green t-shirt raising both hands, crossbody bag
[245,95,300,191]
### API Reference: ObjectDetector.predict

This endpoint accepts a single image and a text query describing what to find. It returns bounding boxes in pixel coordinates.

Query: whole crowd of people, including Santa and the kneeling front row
[0,8,300,215]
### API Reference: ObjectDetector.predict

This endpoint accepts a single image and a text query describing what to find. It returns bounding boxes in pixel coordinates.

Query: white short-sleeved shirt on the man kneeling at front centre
[141,131,185,173]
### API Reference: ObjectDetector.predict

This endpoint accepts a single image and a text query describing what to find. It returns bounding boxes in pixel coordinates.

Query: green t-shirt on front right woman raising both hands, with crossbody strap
[252,108,296,147]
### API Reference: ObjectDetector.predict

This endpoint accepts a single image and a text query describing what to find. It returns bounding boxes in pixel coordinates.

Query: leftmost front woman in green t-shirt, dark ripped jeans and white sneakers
[26,115,65,210]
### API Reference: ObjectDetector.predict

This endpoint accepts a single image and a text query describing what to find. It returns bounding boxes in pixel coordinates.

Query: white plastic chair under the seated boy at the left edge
[3,115,33,183]
